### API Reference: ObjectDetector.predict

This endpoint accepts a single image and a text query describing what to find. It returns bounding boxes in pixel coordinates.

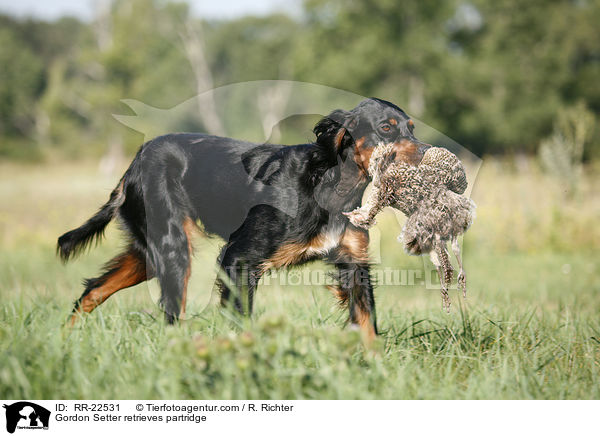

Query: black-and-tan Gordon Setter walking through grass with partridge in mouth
[58,98,429,336]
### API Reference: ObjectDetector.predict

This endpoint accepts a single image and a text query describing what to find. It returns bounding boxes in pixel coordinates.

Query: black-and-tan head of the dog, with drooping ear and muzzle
[314,98,430,179]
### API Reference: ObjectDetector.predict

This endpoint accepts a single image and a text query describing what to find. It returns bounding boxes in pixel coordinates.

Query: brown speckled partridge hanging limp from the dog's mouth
[346,144,475,308]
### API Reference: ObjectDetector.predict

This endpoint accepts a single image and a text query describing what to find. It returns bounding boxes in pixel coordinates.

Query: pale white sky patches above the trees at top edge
[0,0,300,20]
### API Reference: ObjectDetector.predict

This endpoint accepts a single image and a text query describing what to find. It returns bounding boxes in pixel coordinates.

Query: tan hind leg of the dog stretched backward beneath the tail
[69,247,151,325]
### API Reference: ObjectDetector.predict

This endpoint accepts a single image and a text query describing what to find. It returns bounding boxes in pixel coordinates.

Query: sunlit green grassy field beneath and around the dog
[0,159,600,399]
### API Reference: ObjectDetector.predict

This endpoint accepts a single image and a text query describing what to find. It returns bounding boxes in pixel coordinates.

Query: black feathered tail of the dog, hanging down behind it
[56,179,125,262]
